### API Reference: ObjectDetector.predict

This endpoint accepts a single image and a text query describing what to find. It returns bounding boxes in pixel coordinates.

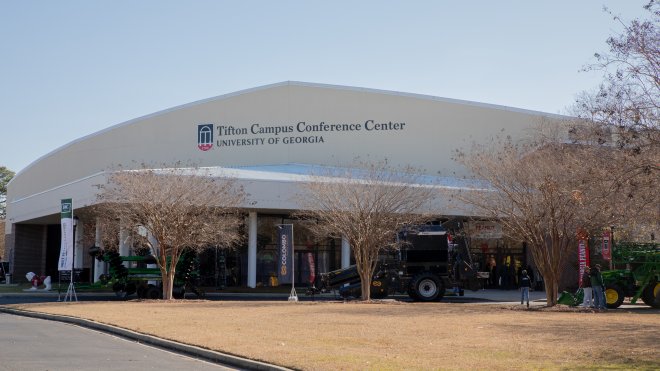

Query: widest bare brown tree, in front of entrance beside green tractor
[453,125,618,306]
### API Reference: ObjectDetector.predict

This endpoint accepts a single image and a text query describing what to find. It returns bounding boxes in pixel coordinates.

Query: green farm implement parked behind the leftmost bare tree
[101,251,204,299]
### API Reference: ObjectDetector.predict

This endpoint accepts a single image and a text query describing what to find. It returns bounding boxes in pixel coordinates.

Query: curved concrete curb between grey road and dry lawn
[0,306,291,371]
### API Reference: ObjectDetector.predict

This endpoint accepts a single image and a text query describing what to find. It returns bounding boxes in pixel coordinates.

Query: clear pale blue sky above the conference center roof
[0,0,646,171]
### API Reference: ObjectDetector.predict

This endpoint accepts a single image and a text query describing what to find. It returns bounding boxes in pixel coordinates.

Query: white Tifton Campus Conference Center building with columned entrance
[5,82,561,287]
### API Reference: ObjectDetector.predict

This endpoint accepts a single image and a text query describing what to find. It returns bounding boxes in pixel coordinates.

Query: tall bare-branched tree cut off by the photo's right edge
[571,1,660,235]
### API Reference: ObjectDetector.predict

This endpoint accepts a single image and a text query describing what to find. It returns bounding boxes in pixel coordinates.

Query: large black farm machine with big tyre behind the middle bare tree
[319,225,480,301]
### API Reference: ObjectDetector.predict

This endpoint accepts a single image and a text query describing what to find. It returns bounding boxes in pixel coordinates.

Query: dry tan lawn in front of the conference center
[15,300,660,370]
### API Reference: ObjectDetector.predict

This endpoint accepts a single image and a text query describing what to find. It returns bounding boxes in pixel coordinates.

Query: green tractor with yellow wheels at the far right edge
[603,243,660,308]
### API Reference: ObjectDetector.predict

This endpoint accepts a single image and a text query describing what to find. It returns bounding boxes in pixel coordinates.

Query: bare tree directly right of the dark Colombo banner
[298,160,434,300]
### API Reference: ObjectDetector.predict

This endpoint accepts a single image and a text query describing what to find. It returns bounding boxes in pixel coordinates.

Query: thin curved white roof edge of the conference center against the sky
[14,81,571,184]
